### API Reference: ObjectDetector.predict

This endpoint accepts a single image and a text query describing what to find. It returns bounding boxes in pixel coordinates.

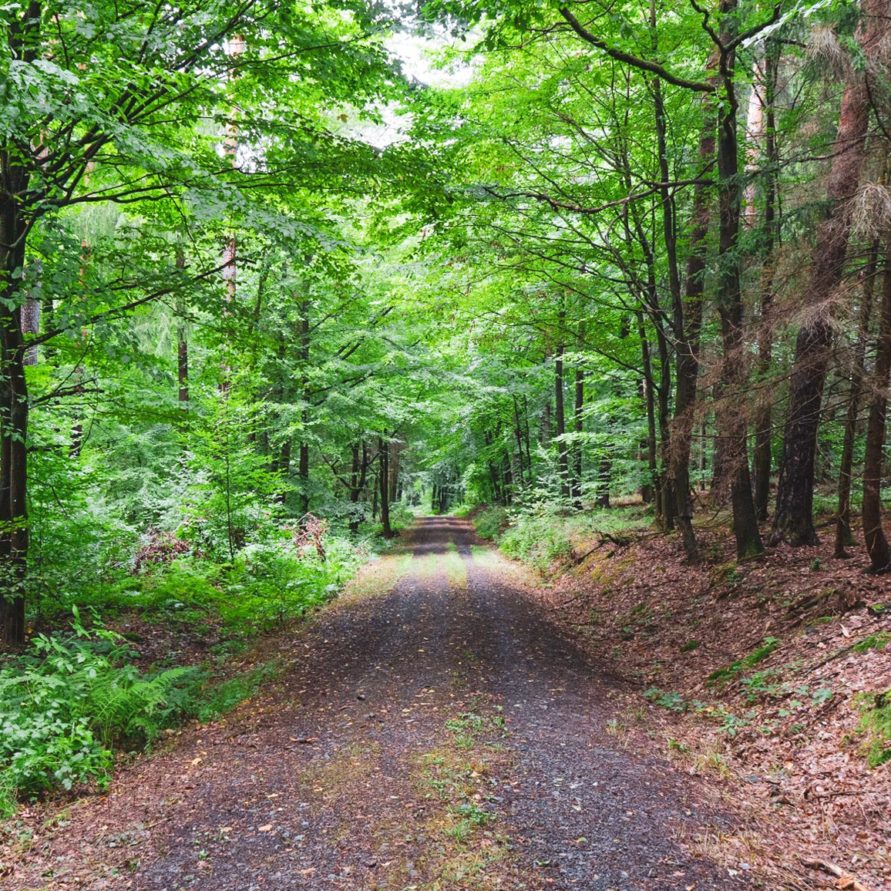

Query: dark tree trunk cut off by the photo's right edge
[862,238,891,572]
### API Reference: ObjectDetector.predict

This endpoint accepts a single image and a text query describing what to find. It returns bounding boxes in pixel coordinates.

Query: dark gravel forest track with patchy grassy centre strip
[4,518,737,891]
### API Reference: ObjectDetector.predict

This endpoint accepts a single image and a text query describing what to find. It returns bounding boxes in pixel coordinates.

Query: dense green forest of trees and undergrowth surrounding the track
[0,0,891,824]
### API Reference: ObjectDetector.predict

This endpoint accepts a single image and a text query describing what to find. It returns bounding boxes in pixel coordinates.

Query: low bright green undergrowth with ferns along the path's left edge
[0,535,371,816]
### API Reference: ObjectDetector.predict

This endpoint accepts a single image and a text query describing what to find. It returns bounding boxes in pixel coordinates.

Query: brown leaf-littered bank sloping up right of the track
[530,508,891,891]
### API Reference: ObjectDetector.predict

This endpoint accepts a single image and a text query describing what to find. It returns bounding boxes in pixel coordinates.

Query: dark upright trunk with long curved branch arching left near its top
[718,0,764,559]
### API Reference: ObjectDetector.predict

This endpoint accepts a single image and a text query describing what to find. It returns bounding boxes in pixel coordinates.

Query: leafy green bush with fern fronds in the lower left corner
[0,612,198,813]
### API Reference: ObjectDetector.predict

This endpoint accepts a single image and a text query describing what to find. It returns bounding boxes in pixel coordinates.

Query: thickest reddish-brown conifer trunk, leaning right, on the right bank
[773,0,891,546]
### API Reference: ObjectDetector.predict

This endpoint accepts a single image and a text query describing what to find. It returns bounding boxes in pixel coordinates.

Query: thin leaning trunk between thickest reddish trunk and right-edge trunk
[835,241,879,558]
